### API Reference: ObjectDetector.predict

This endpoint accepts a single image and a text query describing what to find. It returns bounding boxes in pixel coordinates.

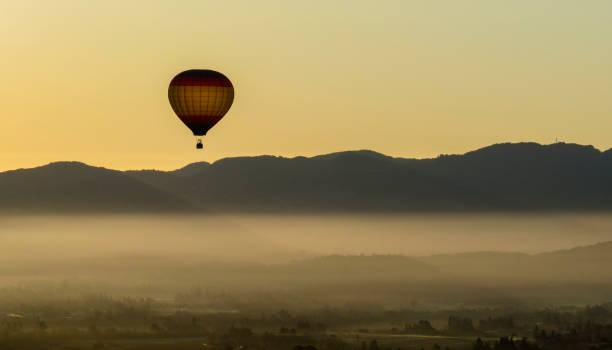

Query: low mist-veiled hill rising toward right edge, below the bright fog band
[285,241,612,285]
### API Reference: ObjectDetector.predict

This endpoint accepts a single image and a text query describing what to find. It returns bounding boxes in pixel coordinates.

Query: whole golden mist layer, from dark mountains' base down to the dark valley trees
[0,214,612,308]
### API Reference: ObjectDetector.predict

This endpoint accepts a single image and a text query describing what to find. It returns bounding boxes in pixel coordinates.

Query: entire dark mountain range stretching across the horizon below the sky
[0,143,612,212]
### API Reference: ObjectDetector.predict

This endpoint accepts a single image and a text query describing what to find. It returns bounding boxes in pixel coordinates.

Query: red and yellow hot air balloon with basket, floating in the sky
[168,69,234,149]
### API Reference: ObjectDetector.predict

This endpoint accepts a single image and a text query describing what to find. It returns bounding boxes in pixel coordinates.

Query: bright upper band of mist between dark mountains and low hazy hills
[0,214,612,263]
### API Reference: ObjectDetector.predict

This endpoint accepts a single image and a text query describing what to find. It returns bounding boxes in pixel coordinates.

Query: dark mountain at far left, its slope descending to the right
[0,162,194,213]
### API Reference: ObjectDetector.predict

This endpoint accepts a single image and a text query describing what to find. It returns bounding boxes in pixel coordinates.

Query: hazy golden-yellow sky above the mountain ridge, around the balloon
[0,0,612,170]
